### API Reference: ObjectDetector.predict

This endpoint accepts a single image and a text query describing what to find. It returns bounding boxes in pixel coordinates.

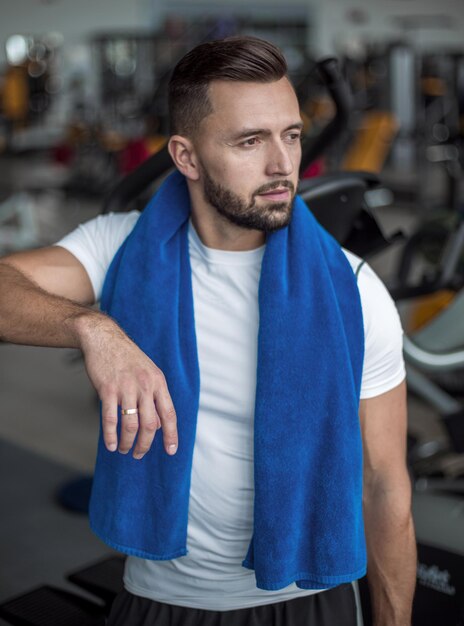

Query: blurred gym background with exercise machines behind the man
[0,0,464,626]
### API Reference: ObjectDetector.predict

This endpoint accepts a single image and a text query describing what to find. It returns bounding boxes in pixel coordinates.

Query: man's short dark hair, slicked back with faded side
[169,36,287,136]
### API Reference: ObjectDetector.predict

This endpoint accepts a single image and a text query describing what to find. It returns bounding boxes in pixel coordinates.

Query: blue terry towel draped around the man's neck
[90,172,366,590]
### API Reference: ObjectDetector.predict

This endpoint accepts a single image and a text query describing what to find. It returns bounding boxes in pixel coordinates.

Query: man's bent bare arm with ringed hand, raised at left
[0,247,177,458]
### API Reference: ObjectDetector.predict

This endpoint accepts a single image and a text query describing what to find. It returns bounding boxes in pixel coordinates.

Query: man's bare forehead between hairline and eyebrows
[204,77,300,132]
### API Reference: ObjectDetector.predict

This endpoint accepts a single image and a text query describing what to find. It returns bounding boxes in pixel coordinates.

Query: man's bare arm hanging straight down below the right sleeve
[360,383,416,626]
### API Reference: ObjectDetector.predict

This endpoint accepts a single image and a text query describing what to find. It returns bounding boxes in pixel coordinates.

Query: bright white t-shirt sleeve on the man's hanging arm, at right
[358,263,406,399]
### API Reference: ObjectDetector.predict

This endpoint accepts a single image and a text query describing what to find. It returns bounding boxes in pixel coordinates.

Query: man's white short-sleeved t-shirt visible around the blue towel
[58,211,405,611]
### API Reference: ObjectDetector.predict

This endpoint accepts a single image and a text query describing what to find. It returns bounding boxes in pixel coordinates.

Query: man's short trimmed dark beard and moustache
[202,167,295,233]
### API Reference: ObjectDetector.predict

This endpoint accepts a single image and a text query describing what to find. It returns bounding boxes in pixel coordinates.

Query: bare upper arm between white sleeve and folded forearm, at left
[1,246,95,304]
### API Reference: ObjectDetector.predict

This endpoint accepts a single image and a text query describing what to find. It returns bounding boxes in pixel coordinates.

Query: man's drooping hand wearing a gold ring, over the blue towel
[76,314,178,459]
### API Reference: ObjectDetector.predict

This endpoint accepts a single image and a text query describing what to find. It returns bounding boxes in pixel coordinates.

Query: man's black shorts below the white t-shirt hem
[107,584,357,626]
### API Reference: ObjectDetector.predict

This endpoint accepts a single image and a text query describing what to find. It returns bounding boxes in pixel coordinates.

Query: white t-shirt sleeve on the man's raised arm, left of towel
[55,211,140,302]
